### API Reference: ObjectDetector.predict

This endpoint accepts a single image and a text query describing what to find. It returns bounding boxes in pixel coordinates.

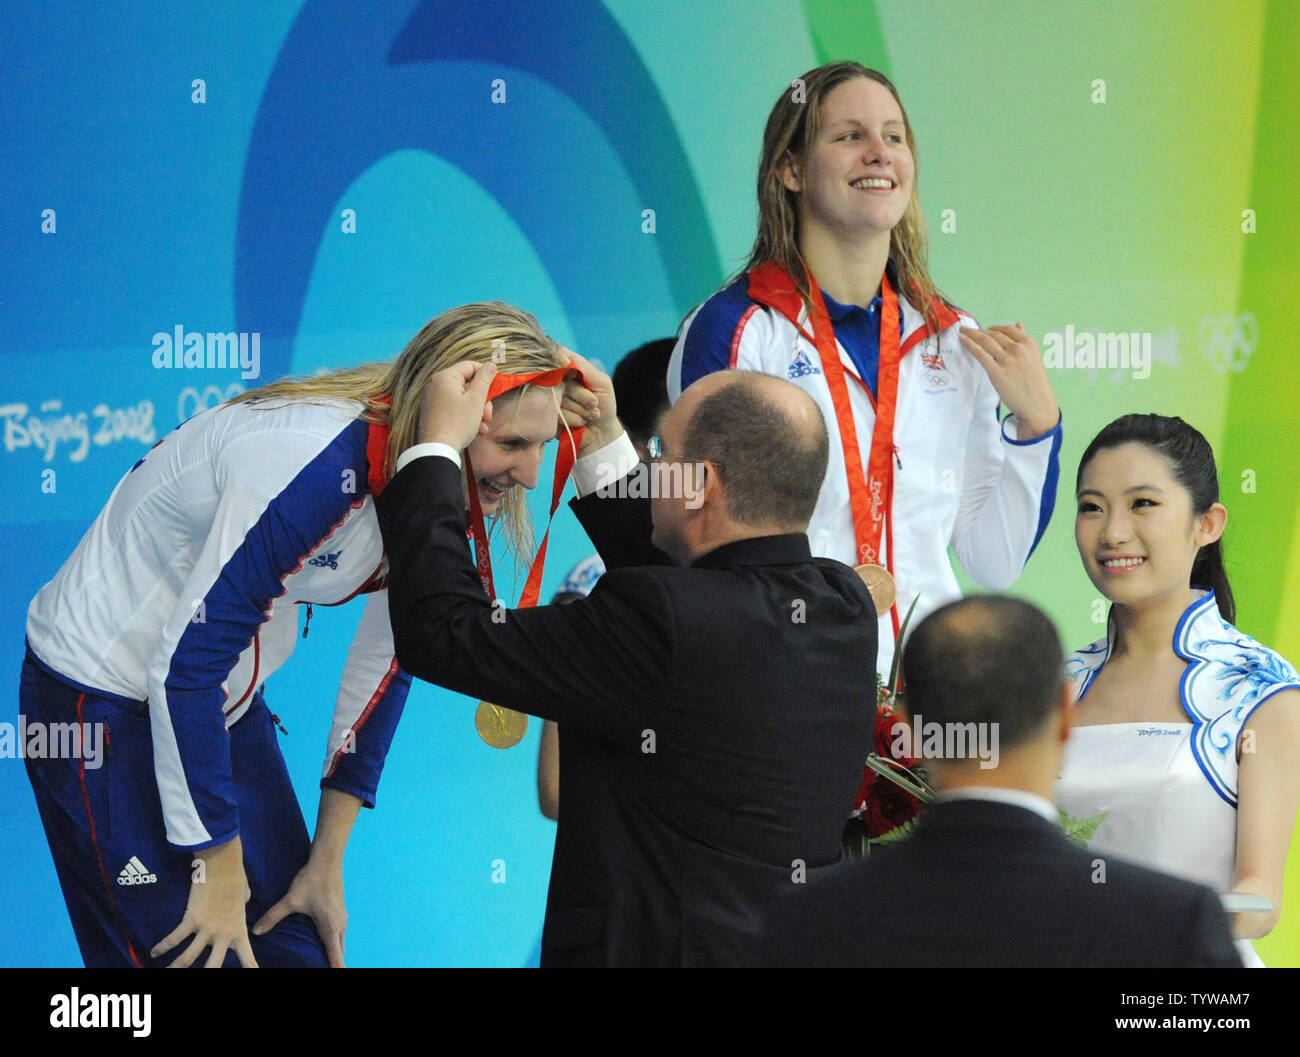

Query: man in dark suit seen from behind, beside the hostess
[763,595,1240,967]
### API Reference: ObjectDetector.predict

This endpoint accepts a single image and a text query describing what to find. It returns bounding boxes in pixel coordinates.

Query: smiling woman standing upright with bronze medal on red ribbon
[668,62,1061,671]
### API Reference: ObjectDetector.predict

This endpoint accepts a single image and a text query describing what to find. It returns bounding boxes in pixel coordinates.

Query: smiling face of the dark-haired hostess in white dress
[1074,443,1227,606]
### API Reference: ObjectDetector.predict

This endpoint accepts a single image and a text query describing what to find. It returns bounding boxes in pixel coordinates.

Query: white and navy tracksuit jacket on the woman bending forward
[27,400,411,849]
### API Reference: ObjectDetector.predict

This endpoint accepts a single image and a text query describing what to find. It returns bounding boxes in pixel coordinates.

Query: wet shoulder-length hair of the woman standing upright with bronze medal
[744,61,946,329]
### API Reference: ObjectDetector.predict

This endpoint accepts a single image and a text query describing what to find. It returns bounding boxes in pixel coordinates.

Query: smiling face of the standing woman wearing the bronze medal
[781,77,915,244]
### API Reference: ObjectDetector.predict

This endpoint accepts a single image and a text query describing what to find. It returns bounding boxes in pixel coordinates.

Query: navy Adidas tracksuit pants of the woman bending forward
[18,650,329,967]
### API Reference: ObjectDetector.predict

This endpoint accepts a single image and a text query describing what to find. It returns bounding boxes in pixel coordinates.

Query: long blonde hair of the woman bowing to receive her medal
[226,300,564,563]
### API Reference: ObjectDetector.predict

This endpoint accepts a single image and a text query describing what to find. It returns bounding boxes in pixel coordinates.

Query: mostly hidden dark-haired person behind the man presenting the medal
[537,338,676,820]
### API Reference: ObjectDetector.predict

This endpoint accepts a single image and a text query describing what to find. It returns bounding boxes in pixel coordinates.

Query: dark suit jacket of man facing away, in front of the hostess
[763,801,1240,969]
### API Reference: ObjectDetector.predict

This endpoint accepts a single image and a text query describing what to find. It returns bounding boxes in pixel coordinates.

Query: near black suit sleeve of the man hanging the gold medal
[376,456,675,741]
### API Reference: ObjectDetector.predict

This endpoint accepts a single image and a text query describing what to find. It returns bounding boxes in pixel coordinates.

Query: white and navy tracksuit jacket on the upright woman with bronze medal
[668,276,1061,673]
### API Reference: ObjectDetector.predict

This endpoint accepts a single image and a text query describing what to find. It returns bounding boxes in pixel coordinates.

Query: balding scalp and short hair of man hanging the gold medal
[675,371,829,532]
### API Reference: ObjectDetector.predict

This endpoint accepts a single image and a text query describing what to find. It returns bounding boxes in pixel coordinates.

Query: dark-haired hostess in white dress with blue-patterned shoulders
[1056,415,1300,966]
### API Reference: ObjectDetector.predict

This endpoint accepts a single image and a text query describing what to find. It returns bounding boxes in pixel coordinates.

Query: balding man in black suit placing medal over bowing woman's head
[377,356,876,966]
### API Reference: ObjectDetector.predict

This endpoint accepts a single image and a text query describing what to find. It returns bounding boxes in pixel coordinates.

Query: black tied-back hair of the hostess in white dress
[1075,415,1236,624]
